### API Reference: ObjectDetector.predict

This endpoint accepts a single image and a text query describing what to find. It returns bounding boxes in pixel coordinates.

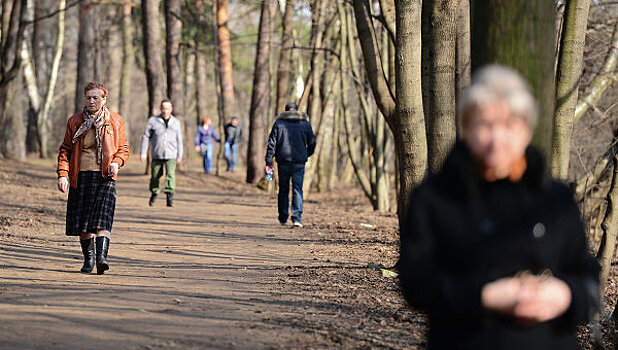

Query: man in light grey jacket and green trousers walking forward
[140,99,183,207]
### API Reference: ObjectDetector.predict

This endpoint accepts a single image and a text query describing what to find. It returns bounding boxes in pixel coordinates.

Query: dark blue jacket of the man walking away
[266,111,315,165]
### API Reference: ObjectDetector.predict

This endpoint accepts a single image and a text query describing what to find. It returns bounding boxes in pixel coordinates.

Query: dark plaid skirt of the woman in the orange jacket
[66,171,116,236]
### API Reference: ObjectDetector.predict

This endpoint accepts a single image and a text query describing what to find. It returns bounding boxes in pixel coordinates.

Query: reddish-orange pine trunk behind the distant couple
[217,0,234,121]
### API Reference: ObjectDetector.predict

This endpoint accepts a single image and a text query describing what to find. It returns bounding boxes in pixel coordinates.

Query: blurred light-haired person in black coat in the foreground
[399,65,600,349]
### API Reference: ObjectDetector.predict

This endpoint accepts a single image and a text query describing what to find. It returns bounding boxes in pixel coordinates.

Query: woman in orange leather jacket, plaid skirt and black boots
[57,82,129,275]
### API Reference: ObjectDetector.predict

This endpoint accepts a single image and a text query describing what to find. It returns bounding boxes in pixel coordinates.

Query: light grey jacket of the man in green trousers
[140,114,182,159]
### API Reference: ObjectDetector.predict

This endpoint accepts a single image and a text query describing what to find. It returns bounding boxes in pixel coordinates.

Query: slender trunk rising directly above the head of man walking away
[276,0,296,113]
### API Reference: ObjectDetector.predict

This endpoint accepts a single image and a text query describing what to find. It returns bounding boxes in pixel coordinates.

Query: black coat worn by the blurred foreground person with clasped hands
[399,144,600,349]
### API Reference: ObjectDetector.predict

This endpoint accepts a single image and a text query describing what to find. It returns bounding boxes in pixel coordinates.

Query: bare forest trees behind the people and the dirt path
[0,0,618,342]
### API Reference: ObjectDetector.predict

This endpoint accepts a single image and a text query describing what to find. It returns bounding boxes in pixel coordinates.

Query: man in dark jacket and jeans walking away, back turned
[266,102,315,227]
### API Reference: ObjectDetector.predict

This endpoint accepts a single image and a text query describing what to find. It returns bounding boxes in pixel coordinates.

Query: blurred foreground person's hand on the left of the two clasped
[481,277,522,315]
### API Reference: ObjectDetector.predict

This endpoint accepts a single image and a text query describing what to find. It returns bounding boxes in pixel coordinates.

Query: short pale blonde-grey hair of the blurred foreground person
[458,64,538,131]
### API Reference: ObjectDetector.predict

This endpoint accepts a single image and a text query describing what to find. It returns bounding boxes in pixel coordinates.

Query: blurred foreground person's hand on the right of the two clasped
[513,276,572,324]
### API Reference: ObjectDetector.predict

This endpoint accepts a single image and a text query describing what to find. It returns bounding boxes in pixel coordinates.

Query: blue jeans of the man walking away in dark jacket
[277,163,305,223]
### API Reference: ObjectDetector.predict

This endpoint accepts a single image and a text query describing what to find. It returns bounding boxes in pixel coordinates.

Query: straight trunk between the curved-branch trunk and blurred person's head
[422,0,459,173]
